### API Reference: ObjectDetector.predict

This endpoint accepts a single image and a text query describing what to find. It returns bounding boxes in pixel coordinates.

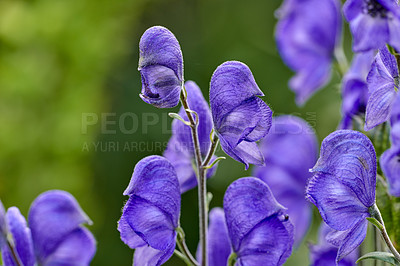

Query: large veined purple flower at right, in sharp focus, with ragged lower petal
[306,130,376,262]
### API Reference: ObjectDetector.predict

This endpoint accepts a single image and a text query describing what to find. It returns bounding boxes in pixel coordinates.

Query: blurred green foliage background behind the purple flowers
[0,0,362,265]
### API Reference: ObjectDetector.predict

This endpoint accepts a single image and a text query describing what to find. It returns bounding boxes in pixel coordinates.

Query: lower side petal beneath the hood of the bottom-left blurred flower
[45,227,96,266]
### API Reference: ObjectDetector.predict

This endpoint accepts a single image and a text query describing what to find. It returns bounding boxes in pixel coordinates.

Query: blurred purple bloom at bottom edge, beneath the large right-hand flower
[310,222,359,266]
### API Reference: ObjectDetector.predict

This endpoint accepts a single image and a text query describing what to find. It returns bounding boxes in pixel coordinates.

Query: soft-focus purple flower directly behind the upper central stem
[164,81,216,193]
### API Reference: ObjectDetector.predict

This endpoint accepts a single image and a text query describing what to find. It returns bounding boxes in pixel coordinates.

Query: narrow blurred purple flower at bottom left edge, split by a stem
[1,207,35,266]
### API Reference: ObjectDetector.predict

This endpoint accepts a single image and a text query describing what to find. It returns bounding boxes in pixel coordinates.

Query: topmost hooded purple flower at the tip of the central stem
[138,26,183,108]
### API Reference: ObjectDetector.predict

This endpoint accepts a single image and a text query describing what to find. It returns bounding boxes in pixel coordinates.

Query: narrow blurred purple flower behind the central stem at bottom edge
[196,208,231,266]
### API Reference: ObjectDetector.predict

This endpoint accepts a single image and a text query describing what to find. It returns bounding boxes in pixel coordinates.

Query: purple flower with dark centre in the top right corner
[343,0,400,52]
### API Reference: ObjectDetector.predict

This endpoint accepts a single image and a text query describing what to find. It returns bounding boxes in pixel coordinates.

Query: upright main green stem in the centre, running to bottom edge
[180,88,208,266]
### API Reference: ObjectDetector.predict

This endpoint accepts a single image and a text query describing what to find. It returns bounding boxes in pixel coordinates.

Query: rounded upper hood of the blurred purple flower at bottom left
[29,190,94,263]
